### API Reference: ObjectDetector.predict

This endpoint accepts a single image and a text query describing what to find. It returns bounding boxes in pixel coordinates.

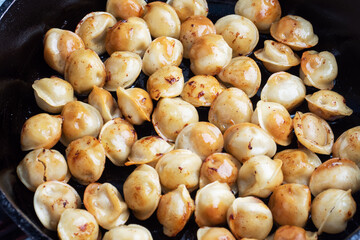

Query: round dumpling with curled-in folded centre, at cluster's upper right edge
[300,50,338,90]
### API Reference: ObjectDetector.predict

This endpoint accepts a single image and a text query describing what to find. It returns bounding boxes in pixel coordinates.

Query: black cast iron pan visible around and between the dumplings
[0,0,360,240]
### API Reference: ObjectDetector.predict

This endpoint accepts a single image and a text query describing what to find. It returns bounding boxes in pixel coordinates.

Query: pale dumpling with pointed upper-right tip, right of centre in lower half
[237,155,283,198]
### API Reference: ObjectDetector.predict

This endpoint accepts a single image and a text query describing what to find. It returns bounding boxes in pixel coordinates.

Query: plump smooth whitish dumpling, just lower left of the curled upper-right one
[261,72,306,112]
